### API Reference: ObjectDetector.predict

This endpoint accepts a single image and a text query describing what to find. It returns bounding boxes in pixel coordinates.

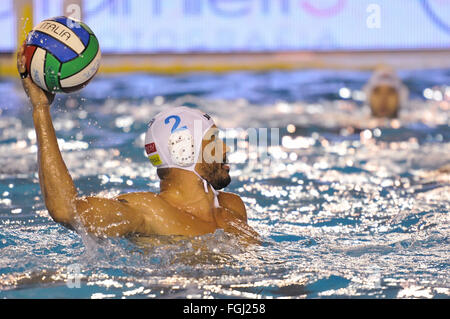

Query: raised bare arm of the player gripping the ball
[17,46,142,236]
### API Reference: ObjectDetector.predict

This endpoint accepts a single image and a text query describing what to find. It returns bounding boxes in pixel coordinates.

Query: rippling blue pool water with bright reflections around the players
[0,70,450,298]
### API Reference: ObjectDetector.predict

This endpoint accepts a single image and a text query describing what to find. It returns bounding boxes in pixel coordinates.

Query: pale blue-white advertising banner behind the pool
[0,0,450,53]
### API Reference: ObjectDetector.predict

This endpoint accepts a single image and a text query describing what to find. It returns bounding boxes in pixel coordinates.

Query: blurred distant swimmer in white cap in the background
[364,67,408,118]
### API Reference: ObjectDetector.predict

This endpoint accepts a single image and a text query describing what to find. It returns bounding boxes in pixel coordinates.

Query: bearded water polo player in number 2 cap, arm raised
[17,43,258,241]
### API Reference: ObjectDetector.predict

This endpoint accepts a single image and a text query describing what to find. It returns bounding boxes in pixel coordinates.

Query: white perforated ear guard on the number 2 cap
[168,129,195,167]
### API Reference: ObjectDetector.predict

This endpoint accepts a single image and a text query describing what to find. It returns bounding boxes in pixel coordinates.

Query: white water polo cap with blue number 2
[145,106,219,207]
